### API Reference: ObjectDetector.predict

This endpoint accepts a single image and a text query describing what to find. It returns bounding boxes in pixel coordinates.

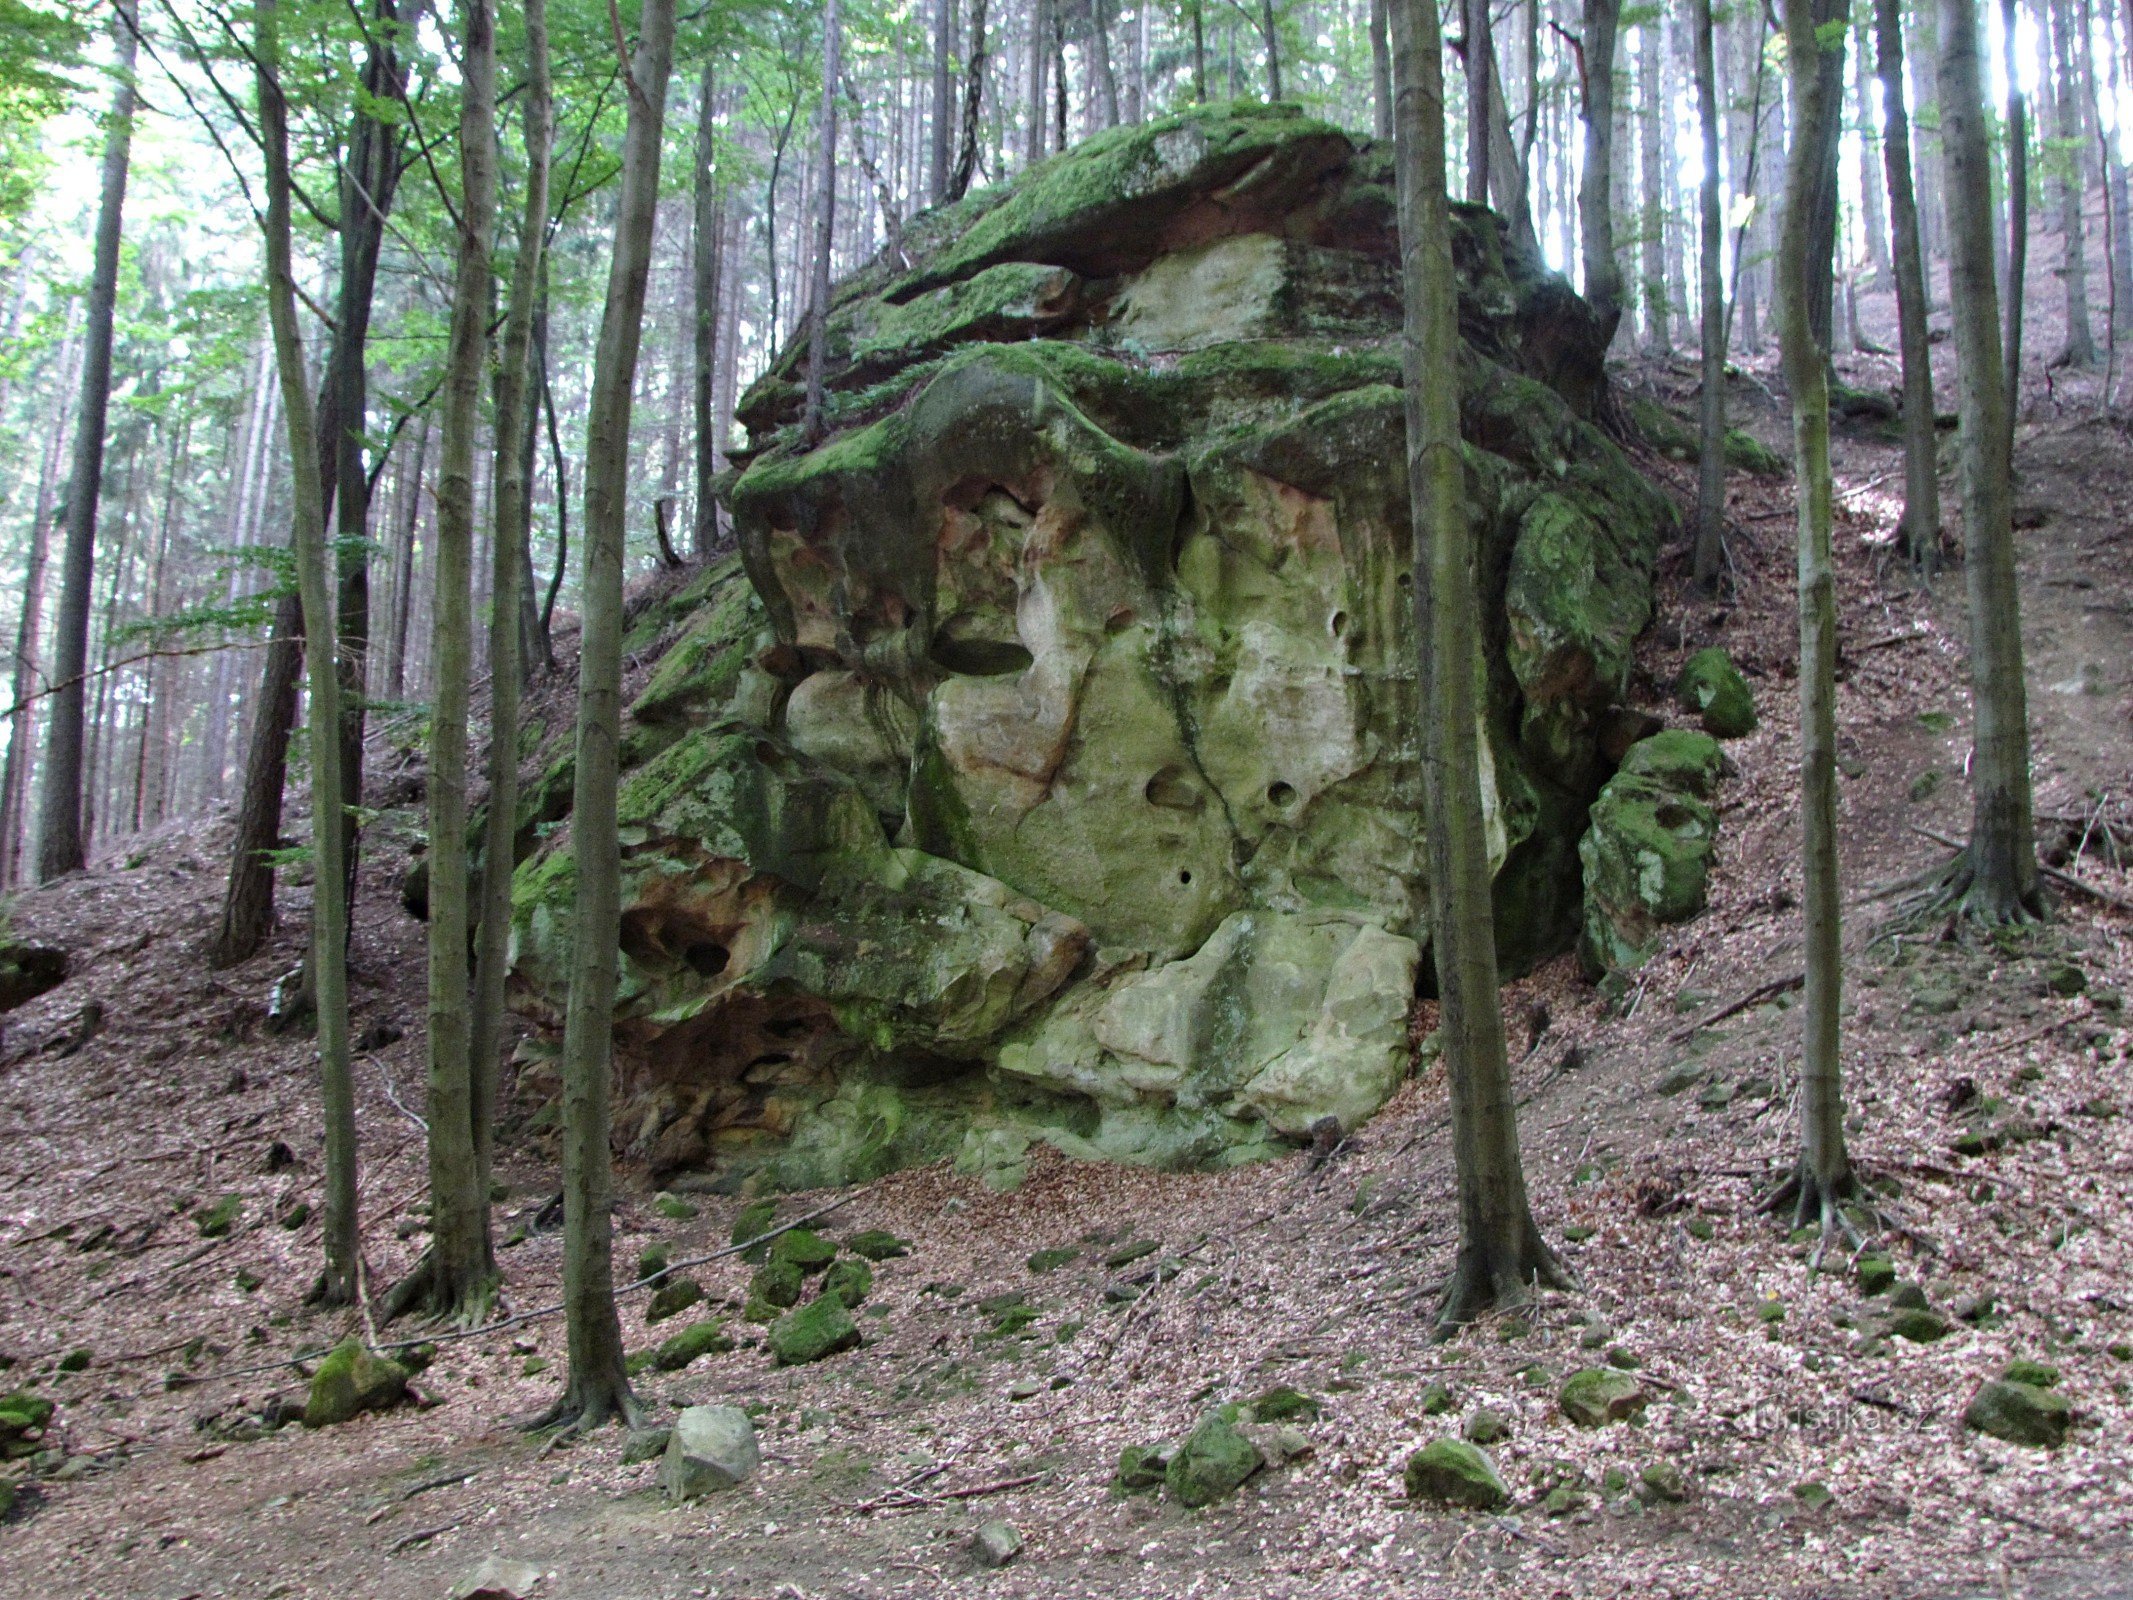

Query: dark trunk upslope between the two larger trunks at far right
[1875,0,1941,572]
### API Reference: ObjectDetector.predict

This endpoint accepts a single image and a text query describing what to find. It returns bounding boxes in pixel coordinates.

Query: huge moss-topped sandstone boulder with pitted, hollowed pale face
[514,107,1672,1188]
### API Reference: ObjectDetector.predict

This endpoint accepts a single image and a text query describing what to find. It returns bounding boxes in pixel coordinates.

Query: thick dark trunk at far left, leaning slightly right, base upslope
[36,0,137,879]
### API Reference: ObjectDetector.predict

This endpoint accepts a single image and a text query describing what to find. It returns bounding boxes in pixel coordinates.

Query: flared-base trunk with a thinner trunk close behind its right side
[392,0,499,1323]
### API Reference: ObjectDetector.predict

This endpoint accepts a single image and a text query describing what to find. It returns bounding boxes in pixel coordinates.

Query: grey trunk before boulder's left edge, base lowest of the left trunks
[537,0,669,1429]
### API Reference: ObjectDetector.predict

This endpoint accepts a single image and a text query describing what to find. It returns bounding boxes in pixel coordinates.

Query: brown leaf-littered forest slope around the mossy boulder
[0,292,2133,1600]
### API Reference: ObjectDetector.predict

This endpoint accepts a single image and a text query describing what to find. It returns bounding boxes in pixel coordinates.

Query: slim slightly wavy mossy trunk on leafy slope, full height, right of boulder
[1777,0,1851,1233]
